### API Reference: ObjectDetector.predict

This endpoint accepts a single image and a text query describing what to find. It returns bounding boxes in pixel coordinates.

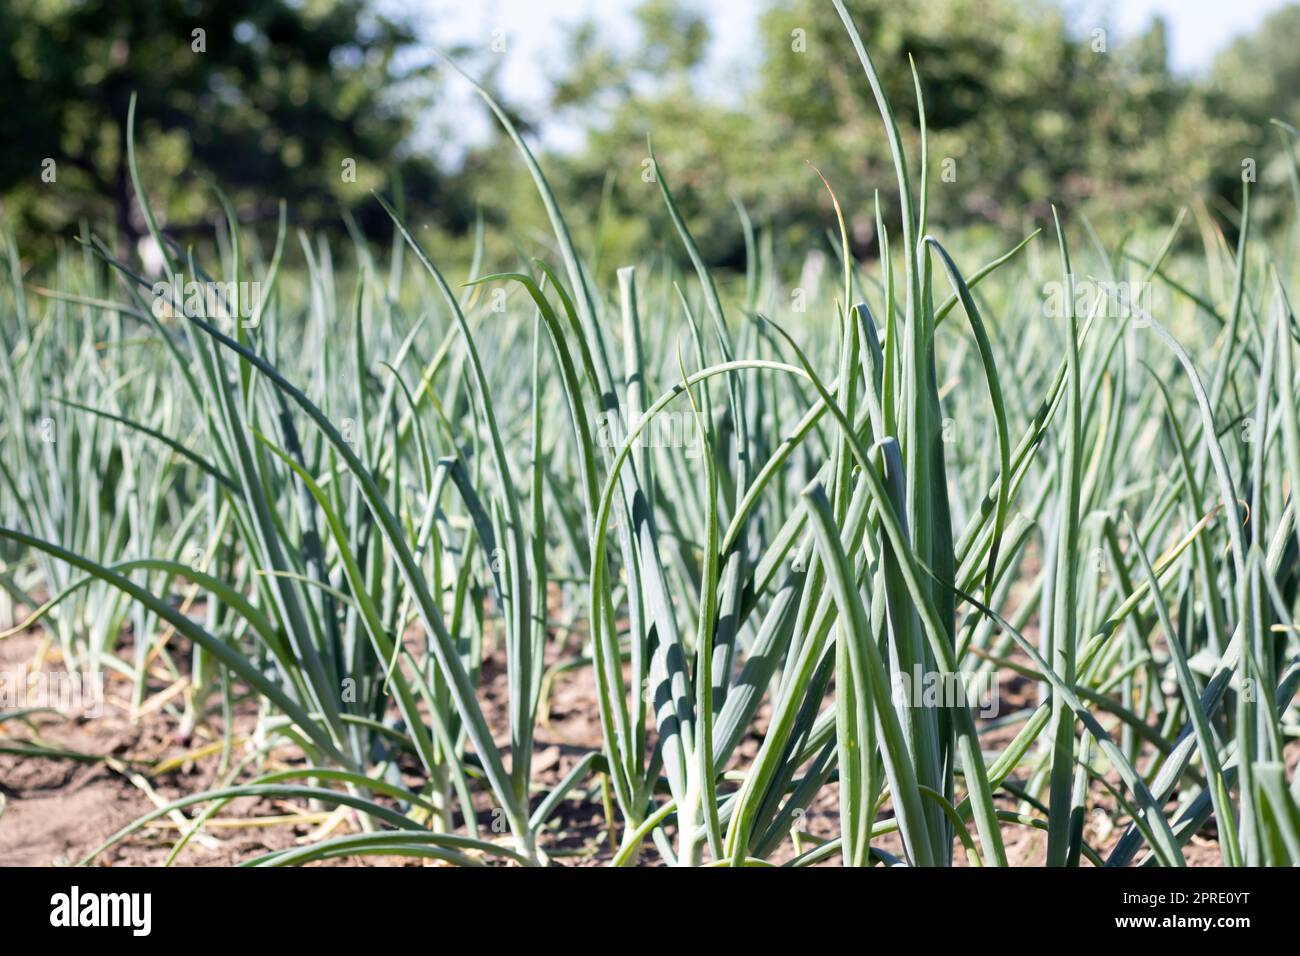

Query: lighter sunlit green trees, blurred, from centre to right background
[457,0,1297,273]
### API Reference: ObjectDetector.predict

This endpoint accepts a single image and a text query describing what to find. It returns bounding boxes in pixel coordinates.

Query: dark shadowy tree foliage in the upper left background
[0,0,460,251]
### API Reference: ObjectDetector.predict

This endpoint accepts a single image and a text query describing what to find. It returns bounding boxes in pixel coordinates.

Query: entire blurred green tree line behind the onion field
[0,0,1300,265]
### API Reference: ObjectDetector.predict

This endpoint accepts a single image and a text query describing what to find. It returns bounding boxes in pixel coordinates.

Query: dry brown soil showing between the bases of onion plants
[0,613,1268,866]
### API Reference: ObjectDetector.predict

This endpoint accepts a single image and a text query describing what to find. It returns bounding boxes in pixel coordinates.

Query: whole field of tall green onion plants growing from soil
[0,0,1300,866]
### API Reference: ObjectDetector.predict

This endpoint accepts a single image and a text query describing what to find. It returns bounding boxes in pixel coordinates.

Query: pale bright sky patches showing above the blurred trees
[397,0,1287,157]
